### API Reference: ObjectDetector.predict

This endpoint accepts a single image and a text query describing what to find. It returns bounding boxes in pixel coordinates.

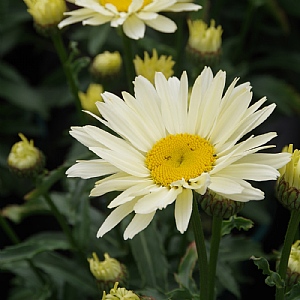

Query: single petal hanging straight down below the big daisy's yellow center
[175,189,193,233]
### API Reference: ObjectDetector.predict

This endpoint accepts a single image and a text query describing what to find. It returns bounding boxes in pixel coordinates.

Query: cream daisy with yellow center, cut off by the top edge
[59,0,201,39]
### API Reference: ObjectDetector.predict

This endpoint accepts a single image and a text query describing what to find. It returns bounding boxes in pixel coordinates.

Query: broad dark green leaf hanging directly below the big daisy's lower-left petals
[129,222,168,290]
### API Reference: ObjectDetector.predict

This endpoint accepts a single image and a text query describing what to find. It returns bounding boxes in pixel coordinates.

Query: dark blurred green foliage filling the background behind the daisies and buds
[0,0,300,300]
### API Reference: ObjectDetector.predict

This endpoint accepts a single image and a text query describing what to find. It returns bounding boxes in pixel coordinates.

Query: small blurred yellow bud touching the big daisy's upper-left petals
[78,83,103,114]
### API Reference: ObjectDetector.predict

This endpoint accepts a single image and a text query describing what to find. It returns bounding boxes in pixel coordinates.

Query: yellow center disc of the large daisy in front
[145,133,216,187]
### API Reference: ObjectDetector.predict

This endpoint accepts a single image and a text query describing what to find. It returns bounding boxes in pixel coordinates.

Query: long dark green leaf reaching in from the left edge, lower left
[0,232,70,267]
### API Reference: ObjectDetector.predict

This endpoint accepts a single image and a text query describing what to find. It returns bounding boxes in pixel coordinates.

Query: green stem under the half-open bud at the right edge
[275,210,300,300]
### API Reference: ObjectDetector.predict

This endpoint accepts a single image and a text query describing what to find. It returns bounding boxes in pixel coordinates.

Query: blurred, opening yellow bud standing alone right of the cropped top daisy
[187,20,223,65]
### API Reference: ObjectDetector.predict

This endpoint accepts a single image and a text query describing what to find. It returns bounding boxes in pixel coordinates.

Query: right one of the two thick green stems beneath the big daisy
[208,216,223,300]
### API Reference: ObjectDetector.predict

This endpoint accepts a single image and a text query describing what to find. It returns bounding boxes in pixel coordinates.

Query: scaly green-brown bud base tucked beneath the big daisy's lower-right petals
[199,190,245,219]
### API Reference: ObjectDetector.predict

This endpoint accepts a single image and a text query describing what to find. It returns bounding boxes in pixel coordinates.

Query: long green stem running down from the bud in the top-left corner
[51,30,85,124]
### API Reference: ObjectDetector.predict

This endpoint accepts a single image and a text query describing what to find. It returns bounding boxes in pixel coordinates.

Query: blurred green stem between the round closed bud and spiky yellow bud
[122,30,135,94]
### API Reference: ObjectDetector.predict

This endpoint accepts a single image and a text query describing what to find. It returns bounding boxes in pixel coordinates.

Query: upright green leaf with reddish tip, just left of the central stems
[175,243,198,291]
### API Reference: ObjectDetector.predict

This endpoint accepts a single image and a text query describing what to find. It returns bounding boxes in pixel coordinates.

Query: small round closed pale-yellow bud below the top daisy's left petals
[91,51,122,79]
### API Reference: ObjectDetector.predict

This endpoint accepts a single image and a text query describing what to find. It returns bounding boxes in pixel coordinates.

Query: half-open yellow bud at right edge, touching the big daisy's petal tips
[276,144,300,211]
